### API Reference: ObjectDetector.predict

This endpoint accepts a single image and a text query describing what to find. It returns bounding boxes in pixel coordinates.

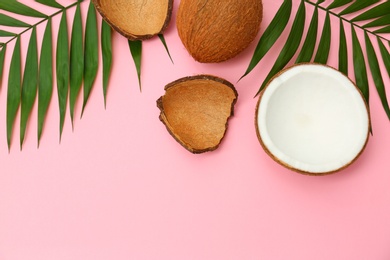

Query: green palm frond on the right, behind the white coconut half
[244,0,390,122]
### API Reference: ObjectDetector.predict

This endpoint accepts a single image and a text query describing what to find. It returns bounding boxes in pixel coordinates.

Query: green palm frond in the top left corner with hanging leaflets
[0,0,112,149]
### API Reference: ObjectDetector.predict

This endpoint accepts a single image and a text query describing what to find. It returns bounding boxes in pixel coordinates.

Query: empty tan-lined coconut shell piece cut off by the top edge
[92,0,173,40]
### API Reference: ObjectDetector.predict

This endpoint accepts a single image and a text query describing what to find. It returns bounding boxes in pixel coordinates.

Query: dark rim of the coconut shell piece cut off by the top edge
[92,0,174,41]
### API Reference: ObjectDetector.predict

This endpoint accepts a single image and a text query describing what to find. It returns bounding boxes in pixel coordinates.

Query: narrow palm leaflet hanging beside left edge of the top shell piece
[101,20,112,107]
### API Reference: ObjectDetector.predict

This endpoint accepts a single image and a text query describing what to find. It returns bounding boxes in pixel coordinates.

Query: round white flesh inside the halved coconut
[257,64,370,174]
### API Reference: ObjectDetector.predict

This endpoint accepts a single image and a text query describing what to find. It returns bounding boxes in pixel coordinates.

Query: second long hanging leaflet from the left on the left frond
[20,27,38,149]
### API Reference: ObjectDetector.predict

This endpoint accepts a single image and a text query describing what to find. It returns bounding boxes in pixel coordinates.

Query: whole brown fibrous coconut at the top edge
[176,0,263,63]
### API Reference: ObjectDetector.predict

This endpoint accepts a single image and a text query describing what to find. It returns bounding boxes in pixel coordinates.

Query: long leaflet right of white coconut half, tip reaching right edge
[364,32,390,119]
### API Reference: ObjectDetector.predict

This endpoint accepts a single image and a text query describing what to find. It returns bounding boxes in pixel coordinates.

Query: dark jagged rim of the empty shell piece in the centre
[156,74,238,154]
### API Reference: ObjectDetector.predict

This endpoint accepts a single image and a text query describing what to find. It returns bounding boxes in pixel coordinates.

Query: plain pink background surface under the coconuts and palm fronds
[0,0,390,260]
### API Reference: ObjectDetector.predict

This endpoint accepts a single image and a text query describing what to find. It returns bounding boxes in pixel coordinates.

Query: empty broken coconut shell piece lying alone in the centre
[157,75,238,153]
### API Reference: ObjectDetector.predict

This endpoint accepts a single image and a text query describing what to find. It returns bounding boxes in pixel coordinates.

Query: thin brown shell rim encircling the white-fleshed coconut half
[254,62,371,176]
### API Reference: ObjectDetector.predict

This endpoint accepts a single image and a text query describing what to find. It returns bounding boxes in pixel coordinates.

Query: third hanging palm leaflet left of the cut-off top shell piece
[69,4,84,126]
